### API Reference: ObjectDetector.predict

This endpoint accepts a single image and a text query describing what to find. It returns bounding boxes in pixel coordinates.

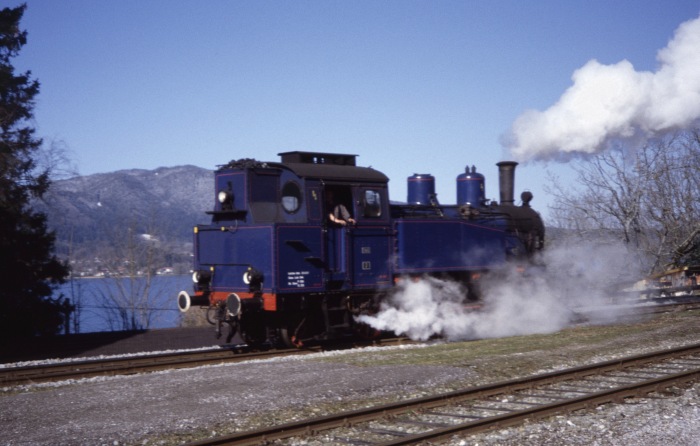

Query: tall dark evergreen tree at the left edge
[0,5,69,342]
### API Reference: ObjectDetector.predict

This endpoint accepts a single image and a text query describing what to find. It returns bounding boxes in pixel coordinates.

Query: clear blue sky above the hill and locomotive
[12,0,700,220]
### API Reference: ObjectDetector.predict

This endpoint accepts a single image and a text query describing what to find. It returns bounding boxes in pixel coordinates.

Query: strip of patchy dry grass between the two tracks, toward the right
[318,311,700,381]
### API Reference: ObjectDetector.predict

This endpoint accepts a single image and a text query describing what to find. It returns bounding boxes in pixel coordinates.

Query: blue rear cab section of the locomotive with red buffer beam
[179,152,391,344]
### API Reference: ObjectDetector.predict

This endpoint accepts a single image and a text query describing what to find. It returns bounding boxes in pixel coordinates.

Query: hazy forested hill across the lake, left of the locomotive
[35,166,214,274]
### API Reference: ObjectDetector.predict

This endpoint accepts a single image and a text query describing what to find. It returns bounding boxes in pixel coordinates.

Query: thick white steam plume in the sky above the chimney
[502,17,700,161]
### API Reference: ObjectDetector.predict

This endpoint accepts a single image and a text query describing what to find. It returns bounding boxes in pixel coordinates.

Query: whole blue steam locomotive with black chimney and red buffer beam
[178,151,544,346]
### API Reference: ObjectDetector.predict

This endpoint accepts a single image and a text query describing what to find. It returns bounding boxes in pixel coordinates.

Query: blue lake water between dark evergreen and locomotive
[54,275,192,333]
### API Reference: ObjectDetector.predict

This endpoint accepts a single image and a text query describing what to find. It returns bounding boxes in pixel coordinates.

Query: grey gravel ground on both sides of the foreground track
[0,313,700,446]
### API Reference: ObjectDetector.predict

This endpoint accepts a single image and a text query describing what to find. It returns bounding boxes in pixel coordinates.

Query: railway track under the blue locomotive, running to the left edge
[0,338,411,387]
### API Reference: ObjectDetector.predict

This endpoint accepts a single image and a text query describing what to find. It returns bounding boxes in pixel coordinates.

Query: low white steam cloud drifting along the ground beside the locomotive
[358,242,635,341]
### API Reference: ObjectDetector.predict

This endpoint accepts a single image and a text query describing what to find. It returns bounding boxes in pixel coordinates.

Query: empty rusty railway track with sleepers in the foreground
[183,344,700,446]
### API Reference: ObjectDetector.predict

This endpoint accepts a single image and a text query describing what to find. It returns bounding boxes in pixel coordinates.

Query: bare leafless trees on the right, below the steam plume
[547,129,700,272]
